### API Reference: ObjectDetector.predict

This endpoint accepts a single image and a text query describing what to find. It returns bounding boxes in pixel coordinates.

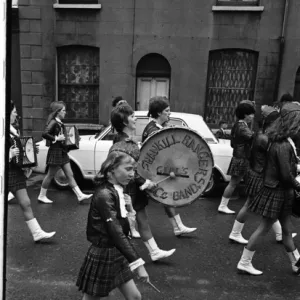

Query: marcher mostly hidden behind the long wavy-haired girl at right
[229,105,296,244]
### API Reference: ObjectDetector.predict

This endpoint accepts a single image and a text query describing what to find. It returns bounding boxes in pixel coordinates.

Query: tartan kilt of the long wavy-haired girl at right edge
[248,186,295,219]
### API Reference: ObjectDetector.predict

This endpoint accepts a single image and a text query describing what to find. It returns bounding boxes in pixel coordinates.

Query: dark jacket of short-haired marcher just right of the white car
[231,121,254,158]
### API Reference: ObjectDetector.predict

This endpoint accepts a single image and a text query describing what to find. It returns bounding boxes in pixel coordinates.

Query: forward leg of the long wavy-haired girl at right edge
[279,216,300,273]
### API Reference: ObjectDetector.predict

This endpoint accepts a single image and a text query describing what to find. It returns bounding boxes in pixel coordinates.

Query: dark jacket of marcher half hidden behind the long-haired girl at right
[250,132,269,173]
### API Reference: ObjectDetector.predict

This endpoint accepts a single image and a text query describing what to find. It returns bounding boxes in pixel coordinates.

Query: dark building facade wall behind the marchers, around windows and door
[19,0,292,135]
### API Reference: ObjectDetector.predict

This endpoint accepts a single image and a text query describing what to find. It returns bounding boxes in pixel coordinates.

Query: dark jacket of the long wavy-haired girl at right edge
[264,140,300,191]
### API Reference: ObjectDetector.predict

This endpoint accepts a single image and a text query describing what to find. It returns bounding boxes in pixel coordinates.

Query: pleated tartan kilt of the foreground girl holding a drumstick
[76,245,133,297]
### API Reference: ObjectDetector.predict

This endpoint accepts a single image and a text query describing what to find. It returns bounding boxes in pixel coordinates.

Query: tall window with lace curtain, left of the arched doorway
[58,46,99,124]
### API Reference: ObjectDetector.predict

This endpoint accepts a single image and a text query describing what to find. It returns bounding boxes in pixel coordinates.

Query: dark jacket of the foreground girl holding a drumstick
[86,180,140,263]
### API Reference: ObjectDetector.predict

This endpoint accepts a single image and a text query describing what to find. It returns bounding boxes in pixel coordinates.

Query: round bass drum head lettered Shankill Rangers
[138,127,214,206]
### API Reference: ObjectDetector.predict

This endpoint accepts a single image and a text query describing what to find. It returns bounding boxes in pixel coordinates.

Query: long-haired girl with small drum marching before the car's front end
[38,101,92,203]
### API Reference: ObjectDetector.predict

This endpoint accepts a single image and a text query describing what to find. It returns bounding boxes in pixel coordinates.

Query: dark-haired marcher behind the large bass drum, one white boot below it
[142,96,197,236]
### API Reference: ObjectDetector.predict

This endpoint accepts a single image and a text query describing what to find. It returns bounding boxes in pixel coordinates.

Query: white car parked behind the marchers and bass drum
[34,111,232,195]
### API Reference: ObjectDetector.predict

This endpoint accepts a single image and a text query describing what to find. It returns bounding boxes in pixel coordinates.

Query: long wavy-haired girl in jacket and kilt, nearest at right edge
[237,103,300,275]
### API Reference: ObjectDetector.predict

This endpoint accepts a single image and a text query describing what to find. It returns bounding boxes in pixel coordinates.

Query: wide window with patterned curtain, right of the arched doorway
[205,49,258,128]
